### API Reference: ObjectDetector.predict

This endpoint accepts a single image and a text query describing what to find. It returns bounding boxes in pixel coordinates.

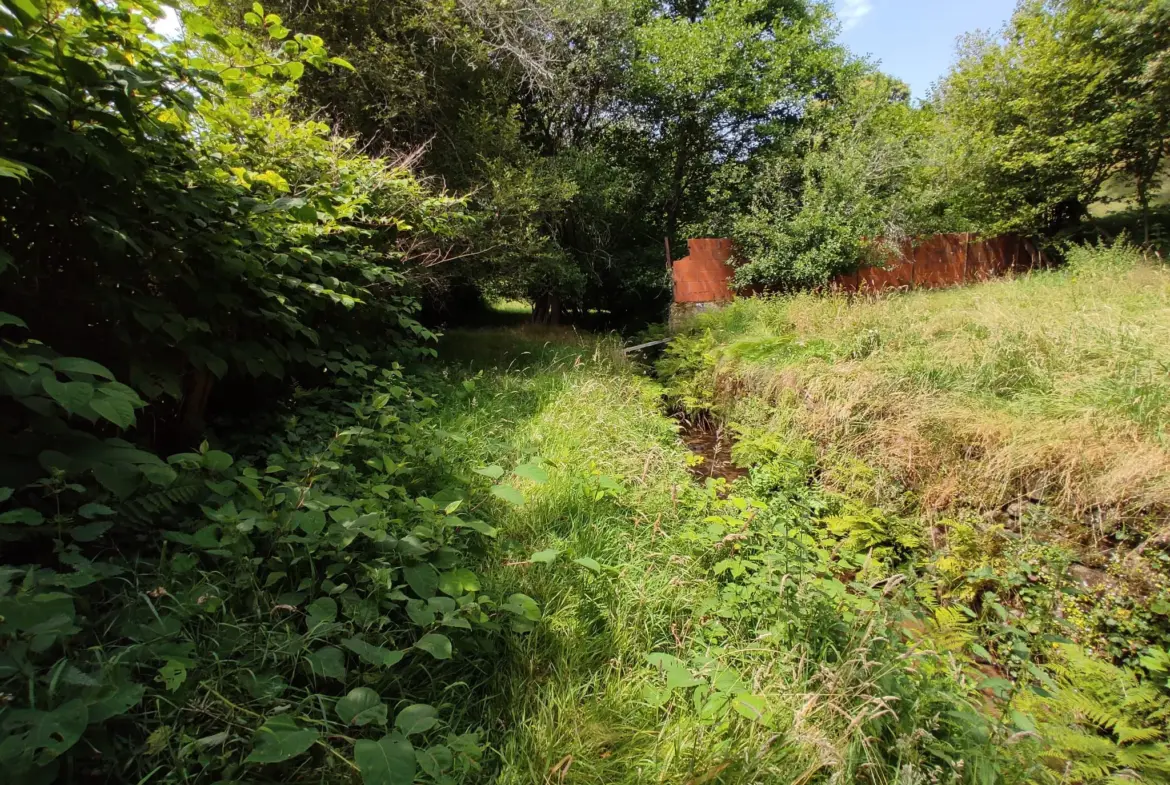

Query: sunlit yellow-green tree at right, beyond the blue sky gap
[932,0,1170,240]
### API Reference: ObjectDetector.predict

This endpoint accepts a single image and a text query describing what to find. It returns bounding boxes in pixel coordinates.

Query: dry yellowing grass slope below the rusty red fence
[678,248,1170,528]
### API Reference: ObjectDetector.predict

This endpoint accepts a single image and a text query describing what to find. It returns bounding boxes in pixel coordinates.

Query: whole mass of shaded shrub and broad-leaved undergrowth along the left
[0,0,539,783]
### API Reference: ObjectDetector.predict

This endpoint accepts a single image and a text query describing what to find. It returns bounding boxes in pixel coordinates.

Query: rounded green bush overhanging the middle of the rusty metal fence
[710,73,966,289]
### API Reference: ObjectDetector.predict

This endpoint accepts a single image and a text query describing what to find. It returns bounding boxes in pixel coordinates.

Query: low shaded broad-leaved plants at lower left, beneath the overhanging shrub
[0,317,539,783]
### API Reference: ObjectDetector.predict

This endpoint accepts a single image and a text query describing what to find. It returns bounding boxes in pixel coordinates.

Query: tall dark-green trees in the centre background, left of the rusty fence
[225,0,844,322]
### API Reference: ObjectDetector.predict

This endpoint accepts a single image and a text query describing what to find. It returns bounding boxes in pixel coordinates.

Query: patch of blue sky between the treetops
[834,0,1016,98]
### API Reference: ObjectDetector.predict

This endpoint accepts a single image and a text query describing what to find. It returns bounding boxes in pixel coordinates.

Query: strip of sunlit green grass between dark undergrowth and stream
[425,331,1001,785]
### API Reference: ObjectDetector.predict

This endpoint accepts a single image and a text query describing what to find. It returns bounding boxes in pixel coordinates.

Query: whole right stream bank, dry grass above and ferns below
[659,246,1170,783]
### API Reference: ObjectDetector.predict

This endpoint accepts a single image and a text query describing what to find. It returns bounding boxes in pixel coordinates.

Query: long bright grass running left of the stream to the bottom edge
[440,329,1034,785]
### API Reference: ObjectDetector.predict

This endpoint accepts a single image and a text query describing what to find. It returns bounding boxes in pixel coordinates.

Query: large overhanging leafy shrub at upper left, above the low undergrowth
[0,4,470,440]
